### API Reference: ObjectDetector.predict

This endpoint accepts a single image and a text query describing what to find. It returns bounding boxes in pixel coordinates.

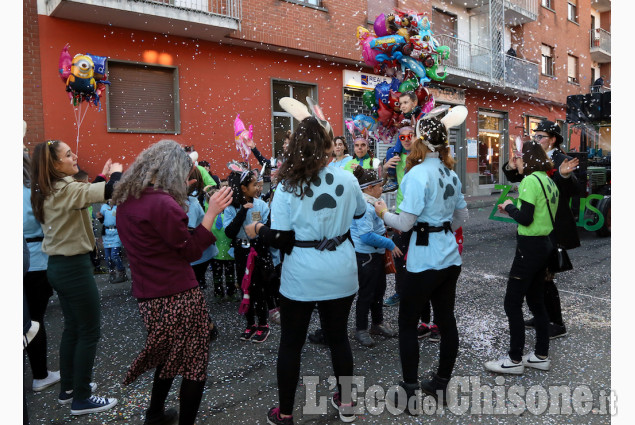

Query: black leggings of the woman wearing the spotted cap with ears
[399,266,461,384]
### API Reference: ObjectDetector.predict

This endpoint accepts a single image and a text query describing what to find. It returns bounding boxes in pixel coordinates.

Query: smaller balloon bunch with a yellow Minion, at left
[59,44,110,111]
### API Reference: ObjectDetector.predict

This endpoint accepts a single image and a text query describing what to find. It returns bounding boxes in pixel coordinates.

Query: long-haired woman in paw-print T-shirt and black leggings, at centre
[245,105,366,425]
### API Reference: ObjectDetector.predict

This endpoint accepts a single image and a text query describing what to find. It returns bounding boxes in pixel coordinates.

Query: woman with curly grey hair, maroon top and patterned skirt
[113,140,232,425]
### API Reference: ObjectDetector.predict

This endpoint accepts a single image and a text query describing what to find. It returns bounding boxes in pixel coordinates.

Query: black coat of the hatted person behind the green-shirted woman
[503,149,580,249]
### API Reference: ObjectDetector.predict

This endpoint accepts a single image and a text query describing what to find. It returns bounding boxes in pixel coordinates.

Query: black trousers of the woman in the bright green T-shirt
[505,235,552,361]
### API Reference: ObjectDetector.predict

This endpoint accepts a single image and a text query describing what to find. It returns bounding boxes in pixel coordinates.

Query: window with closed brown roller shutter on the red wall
[106,59,181,134]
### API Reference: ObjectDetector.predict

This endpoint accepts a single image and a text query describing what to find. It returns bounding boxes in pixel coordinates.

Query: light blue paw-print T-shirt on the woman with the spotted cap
[399,157,467,273]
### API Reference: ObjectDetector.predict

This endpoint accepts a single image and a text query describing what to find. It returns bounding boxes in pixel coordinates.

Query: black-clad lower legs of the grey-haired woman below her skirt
[146,366,205,425]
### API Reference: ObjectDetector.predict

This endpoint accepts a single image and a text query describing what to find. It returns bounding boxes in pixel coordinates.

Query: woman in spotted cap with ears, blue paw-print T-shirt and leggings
[375,118,467,414]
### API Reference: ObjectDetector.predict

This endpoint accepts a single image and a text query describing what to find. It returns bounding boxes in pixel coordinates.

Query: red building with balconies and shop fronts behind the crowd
[24,0,611,195]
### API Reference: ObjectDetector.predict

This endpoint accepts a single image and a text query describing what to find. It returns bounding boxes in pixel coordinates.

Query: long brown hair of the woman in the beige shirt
[31,140,65,223]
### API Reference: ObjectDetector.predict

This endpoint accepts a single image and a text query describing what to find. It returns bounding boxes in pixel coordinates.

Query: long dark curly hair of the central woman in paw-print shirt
[278,117,333,198]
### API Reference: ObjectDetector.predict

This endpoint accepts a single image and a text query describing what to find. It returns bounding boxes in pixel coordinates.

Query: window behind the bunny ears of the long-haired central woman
[271,80,318,157]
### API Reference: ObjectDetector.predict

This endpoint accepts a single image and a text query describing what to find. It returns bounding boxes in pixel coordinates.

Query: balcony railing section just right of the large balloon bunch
[435,35,492,81]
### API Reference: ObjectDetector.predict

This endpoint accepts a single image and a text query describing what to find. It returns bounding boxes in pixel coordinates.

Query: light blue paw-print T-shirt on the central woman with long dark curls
[271,167,366,301]
